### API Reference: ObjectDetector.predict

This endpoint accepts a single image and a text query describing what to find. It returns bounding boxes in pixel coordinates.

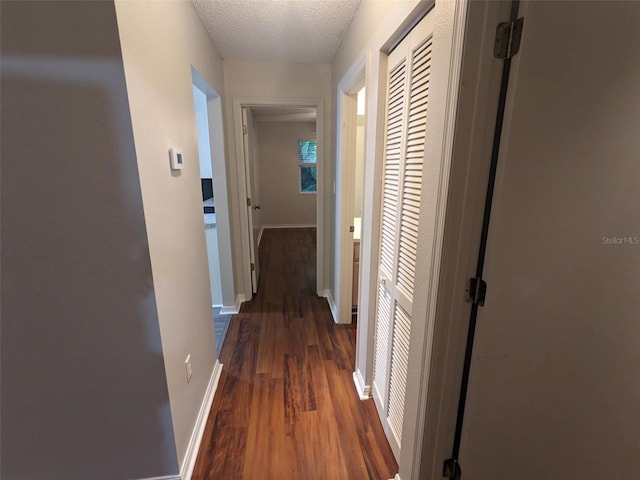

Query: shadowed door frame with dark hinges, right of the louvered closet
[416,0,512,478]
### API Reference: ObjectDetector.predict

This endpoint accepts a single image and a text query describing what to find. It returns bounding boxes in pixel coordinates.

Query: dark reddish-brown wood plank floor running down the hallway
[192,228,398,480]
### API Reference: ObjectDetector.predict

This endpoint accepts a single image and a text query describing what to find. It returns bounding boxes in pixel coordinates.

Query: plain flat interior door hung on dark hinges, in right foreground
[460,1,640,480]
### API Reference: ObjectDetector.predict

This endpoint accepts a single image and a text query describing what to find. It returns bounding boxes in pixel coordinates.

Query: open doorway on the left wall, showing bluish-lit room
[192,69,236,356]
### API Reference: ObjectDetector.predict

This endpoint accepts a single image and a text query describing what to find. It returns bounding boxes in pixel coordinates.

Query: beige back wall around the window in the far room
[256,122,317,227]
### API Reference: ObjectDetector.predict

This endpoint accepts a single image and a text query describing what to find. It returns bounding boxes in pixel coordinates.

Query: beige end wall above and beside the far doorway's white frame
[224,60,334,291]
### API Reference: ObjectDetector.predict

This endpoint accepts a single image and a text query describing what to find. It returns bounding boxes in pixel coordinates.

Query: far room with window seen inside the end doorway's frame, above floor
[242,106,318,294]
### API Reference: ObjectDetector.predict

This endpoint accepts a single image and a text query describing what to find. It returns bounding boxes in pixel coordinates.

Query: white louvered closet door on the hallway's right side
[373,13,433,458]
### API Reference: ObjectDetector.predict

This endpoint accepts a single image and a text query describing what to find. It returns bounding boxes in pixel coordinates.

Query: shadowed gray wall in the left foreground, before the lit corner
[0,2,178,480]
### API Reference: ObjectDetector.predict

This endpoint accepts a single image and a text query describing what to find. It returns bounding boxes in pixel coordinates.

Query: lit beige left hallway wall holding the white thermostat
[116,1,229,468]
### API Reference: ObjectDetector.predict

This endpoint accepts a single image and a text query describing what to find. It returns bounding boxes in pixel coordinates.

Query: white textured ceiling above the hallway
[192,0,360,63]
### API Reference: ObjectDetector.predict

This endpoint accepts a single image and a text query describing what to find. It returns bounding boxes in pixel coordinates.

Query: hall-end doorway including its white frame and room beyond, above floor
[234,99,324,298]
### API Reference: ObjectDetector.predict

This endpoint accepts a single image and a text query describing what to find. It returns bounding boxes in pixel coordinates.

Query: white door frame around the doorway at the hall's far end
[233,97,327,299]
